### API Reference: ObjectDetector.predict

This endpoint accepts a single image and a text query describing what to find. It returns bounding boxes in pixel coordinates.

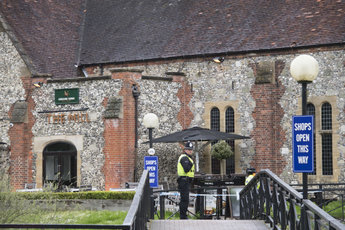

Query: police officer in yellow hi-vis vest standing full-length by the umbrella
[177,142,194,219]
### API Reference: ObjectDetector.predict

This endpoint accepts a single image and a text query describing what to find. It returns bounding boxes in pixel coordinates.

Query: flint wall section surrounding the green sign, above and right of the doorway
[32,79,122,190]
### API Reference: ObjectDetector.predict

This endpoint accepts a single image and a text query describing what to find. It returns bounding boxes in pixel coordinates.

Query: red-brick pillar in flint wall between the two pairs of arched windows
[251,61,286,175]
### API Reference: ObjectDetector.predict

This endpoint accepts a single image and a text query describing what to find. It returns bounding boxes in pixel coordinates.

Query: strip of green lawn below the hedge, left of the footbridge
[15,211,127,225]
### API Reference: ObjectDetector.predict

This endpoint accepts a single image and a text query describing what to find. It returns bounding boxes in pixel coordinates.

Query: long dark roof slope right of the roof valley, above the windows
[78,0,345,65]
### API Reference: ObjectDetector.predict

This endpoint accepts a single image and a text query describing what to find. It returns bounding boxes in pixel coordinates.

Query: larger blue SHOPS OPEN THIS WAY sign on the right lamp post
[292,116,314,173]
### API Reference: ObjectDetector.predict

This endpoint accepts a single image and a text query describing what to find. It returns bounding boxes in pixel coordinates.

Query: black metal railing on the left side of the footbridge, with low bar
[0,170,152,230]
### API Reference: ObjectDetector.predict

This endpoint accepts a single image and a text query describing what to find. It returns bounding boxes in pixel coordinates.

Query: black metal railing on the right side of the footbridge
[240,169,345,230]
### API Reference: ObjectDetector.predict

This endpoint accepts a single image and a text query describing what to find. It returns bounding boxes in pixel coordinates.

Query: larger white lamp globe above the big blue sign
[290,54,319,82]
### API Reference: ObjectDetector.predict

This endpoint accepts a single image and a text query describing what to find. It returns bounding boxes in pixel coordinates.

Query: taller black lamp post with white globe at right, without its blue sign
[290,54,319,199]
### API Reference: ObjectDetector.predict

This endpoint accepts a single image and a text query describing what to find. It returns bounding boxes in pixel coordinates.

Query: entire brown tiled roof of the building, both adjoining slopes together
[0,0,345,78]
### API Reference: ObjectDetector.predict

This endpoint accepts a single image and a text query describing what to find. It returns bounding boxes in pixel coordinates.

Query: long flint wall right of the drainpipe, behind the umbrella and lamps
[114,51,345,186]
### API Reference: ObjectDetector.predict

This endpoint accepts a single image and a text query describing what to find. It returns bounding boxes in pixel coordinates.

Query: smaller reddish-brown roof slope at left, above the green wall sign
[0,0,84,78]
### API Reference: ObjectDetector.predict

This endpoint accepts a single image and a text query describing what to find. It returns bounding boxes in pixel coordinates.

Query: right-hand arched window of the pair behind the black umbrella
[225,107,235,174]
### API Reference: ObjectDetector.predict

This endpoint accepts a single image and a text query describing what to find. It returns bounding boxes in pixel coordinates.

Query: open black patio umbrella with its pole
[152,127,250,172]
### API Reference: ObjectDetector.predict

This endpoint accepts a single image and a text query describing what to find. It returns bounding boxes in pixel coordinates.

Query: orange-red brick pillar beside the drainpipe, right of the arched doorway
[103,72,141,190]
